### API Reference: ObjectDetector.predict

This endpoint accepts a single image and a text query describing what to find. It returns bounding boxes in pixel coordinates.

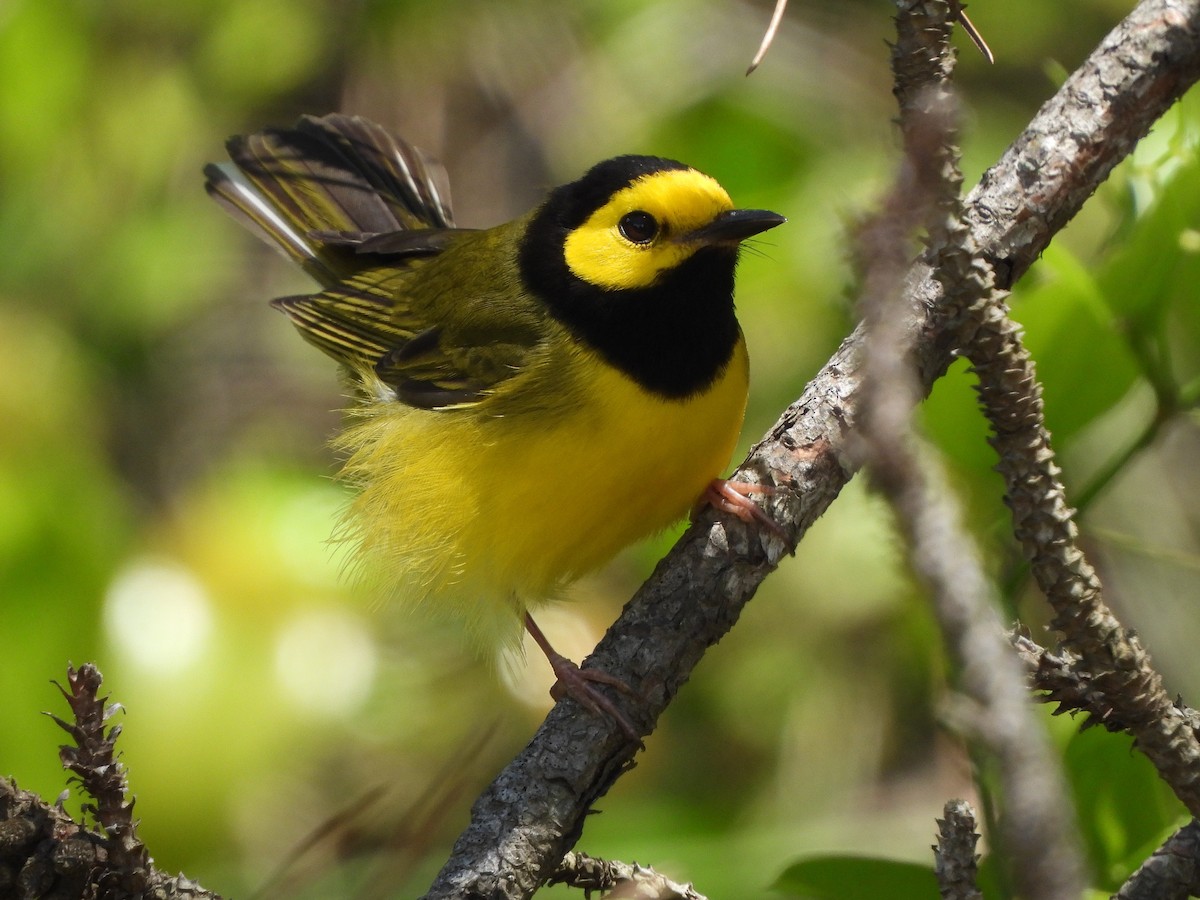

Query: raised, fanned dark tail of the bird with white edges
[204,115,454,286]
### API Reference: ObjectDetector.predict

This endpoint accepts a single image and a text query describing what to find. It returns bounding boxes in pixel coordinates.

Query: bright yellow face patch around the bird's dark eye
[563,169,733,290]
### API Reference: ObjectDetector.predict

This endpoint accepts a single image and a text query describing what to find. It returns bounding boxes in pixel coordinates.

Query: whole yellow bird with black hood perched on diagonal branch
[205,115,785,739]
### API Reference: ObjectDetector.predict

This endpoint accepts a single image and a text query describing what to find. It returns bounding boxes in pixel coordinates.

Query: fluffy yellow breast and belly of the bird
[338,341,749,644]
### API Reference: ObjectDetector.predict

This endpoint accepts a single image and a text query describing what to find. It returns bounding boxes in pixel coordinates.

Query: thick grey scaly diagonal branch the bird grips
[427,0,1200,898]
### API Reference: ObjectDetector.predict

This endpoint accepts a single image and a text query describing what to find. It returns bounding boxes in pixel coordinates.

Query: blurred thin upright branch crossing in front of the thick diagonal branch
[856,0,1084,900]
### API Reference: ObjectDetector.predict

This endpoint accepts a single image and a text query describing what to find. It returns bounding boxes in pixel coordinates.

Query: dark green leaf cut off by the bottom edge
[772,856,937,900]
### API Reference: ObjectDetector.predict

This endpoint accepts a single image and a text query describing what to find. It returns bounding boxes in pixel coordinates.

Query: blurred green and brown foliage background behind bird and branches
[0,0,1200,898]
